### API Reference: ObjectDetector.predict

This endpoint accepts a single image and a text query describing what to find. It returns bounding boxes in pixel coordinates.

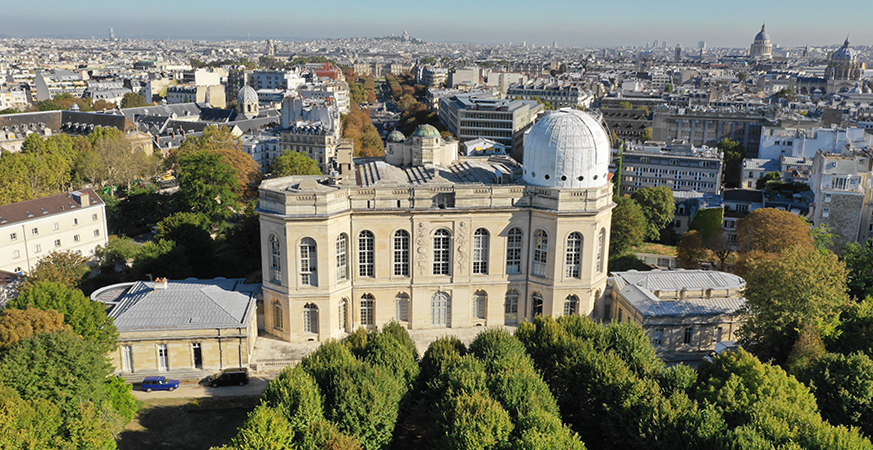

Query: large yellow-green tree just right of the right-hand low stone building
[739,245,849,364]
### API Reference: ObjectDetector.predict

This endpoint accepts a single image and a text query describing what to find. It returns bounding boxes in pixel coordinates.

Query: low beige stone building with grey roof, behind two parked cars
[91,278,261,375]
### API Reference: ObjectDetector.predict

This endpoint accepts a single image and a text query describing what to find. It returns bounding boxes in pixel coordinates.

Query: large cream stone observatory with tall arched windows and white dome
[258,109,615,342]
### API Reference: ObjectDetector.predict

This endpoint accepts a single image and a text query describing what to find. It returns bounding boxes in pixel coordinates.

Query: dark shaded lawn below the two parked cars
[118,396,260,450]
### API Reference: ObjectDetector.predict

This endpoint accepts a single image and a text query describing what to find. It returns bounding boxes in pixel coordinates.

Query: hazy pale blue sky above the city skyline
[0,0,873,47]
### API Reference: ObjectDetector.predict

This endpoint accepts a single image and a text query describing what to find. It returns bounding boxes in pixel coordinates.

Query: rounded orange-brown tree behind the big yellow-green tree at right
[737,208,813,253]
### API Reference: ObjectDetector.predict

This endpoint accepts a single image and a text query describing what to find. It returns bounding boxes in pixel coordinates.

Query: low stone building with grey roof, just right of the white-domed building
[604,269,746,361]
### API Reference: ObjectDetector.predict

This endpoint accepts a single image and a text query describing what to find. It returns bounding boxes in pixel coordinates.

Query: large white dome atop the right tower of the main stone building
[523,108,612,188]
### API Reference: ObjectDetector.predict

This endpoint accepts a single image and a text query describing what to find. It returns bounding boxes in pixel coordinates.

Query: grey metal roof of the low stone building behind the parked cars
[91,279,260,332]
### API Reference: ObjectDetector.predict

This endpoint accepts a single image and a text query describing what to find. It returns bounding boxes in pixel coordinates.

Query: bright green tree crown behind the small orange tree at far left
[8,281,118,354]
